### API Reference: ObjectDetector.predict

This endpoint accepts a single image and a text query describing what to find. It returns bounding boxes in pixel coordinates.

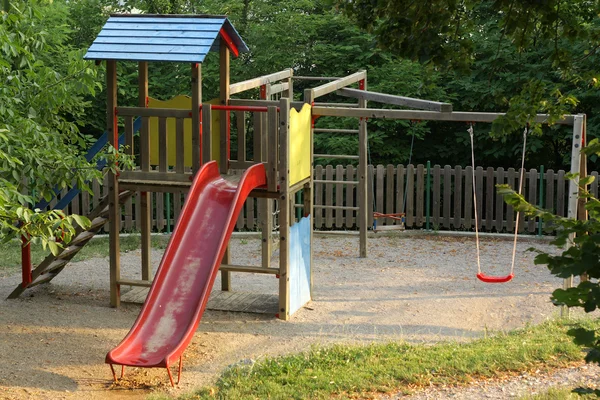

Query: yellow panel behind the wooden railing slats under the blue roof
[148,95,221,167]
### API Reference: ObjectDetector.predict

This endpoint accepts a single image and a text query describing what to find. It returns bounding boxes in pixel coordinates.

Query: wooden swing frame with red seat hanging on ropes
[302,75,586,287]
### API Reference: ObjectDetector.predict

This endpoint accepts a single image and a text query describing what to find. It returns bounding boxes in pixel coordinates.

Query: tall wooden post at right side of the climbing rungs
[358,74,371,258]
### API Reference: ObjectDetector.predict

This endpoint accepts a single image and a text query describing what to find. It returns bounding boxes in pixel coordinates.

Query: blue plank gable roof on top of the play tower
[84,14,248,63]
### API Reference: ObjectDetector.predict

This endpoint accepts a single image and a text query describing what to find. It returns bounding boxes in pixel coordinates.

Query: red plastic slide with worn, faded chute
[106,161,266,383]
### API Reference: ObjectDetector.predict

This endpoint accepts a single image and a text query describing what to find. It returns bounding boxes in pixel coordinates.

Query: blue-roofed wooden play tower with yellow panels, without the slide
[85,14,312,319]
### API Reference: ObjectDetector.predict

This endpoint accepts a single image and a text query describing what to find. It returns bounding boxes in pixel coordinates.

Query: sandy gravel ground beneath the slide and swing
[0,235,598,399]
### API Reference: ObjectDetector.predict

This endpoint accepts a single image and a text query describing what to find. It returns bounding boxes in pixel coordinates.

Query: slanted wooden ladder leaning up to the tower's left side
[8,191,134,299]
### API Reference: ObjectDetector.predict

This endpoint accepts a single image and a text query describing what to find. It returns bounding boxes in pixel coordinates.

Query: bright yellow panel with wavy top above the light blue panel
[290,104,312,186]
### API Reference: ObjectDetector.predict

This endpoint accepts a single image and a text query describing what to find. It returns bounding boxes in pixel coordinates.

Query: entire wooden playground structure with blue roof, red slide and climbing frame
[11,15,586,383]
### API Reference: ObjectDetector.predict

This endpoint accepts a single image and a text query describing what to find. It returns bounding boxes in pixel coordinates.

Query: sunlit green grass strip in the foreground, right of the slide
[153,321,600,400]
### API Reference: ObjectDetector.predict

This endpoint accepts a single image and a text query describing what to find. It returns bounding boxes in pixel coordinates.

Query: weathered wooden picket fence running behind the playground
[50,164,598,233]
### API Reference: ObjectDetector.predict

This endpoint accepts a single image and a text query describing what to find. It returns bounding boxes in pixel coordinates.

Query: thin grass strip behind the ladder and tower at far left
[0,236,168,272]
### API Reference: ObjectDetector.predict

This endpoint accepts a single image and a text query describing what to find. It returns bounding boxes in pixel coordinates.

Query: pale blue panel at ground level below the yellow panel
[289,216,312,315]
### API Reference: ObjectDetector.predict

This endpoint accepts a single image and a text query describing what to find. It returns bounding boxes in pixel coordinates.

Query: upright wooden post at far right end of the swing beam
[560,114,585,317]
